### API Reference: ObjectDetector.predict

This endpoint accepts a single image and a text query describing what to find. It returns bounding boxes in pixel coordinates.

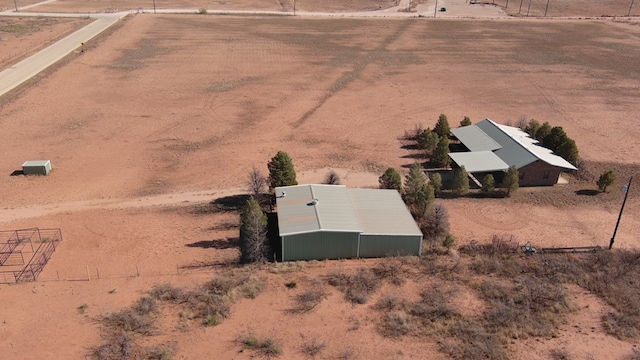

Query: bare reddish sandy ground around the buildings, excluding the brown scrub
[0,14,640,359]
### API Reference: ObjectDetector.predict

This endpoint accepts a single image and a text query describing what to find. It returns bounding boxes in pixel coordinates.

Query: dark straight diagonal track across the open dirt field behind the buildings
[293,21,413,128]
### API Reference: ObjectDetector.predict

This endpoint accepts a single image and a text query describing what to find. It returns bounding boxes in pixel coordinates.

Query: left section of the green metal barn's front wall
[282,231,359,261]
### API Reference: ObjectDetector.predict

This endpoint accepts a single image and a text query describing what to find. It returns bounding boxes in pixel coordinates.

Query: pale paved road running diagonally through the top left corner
[0,12,129,96]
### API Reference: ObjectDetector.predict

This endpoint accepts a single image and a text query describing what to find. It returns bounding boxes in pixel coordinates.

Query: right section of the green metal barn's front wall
[360,235,422,258]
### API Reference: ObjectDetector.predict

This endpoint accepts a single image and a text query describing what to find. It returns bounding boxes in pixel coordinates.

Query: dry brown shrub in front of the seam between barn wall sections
[327,268,381,304]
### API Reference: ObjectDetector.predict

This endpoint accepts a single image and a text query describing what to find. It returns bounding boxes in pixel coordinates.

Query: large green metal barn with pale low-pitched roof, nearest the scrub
[276,185,422,261]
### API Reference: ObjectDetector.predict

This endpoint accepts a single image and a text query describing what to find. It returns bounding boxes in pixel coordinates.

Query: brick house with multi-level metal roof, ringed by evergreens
[449,119,577,186]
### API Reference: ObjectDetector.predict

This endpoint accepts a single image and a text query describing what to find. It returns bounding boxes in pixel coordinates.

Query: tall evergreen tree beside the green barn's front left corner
[240,197,270,263]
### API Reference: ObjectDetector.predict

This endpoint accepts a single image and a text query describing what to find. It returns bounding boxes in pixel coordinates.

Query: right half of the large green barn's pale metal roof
[348,188,422,236]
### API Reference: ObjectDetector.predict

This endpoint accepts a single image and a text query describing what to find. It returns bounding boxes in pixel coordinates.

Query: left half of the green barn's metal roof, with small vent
[276,185,362,235]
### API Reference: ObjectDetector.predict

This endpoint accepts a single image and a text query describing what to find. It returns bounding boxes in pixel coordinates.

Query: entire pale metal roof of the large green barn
[276,185,422,236]
